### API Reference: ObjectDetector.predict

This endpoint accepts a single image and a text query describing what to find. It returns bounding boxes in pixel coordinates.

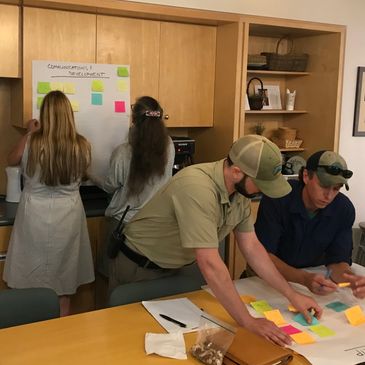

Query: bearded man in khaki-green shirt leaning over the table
[110,135,322,345]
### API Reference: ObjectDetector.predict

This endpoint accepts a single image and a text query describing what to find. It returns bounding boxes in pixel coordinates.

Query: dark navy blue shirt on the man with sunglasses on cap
[255,180,355,268]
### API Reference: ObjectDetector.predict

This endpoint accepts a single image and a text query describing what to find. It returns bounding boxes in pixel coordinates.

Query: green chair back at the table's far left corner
[0,288,60,328]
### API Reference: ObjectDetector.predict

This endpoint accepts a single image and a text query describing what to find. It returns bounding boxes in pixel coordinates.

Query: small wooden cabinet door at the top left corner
[0,5,20,77]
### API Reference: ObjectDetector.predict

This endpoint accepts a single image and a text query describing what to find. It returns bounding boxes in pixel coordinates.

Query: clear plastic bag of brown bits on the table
[190,314,235,365]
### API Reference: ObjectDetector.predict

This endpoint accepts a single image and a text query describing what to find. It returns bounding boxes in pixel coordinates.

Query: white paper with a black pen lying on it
[142,298,204,333]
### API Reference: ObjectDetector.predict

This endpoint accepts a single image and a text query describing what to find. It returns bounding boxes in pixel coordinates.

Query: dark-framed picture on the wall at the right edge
[352,67,365,137]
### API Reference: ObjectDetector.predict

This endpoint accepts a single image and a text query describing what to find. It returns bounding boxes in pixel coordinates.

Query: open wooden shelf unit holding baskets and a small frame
[241,19,345,158]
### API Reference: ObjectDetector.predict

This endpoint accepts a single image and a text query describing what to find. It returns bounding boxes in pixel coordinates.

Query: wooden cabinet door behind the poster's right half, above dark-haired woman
[96,15,160,103]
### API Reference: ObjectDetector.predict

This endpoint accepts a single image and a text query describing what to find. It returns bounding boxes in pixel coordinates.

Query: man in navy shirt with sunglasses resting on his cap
[255,151,365,298]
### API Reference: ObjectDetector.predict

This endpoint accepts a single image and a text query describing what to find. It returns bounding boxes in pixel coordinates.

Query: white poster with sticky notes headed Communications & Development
[32,61,130,177]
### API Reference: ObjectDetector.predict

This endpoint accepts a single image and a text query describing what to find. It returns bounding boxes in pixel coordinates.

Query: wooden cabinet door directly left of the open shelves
[159,23,216,127]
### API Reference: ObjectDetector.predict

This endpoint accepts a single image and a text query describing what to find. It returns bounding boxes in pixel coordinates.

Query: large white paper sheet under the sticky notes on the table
[202,264,365,365]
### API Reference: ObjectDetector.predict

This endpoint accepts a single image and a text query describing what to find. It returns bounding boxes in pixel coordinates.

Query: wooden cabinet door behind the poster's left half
[18,7,96,123]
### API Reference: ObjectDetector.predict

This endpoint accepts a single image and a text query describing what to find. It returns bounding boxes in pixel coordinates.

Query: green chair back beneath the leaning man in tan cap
[109,264,205,307]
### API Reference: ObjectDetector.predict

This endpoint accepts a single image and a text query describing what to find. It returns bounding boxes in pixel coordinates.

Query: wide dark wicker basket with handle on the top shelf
[261,37,309,71]
